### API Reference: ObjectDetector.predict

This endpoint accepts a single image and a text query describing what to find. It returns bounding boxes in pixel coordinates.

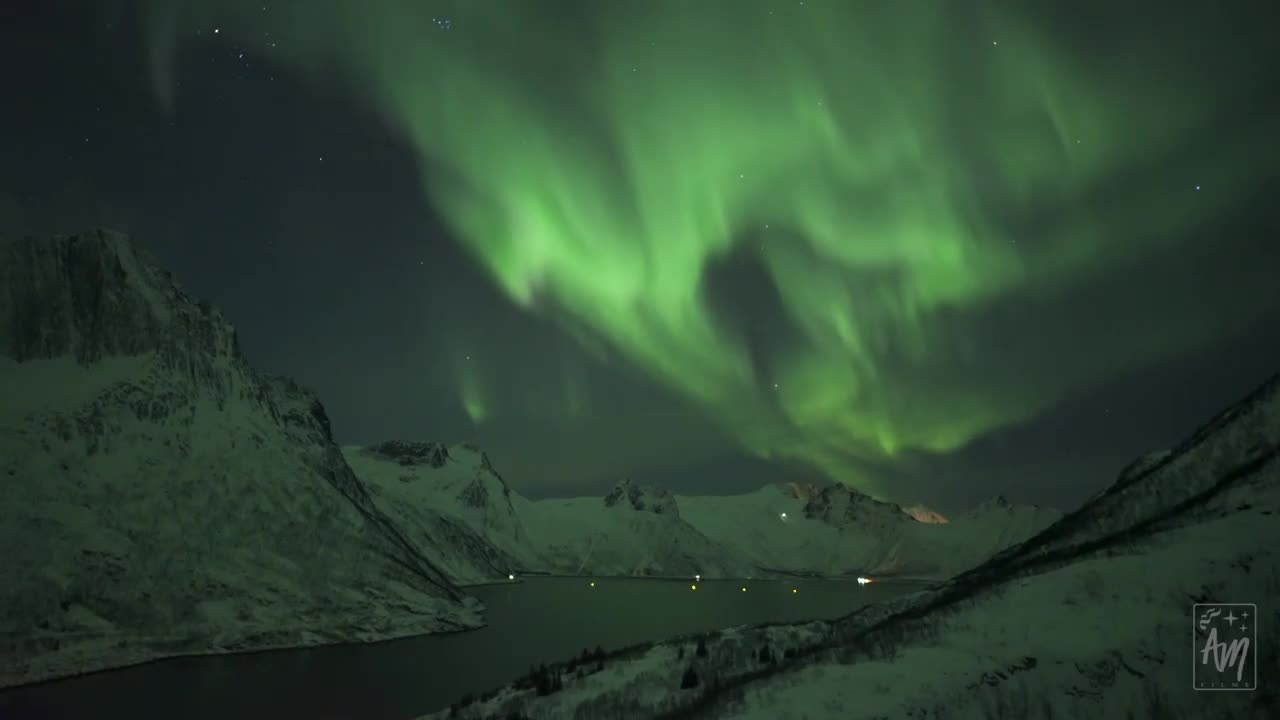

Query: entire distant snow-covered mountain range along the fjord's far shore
[343,441,1059,583]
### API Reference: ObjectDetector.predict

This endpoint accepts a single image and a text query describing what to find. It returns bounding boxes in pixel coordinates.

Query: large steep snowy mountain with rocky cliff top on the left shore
[0,231,479,685]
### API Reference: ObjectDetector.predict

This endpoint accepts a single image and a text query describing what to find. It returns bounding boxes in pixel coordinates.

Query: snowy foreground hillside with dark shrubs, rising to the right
[422,378,1280,720]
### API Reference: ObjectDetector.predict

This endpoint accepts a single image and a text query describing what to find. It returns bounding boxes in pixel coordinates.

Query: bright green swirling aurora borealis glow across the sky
[5,0,1280,502]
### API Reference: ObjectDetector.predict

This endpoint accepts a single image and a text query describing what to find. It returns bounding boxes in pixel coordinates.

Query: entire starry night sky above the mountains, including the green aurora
[0,0,1280,511]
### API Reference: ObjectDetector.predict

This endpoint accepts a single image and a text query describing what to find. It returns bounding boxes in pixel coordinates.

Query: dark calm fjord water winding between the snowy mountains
[0,578,918,720]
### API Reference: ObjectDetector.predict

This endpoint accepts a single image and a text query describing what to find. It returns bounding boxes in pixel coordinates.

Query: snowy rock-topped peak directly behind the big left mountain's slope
[343,441,538,583]
